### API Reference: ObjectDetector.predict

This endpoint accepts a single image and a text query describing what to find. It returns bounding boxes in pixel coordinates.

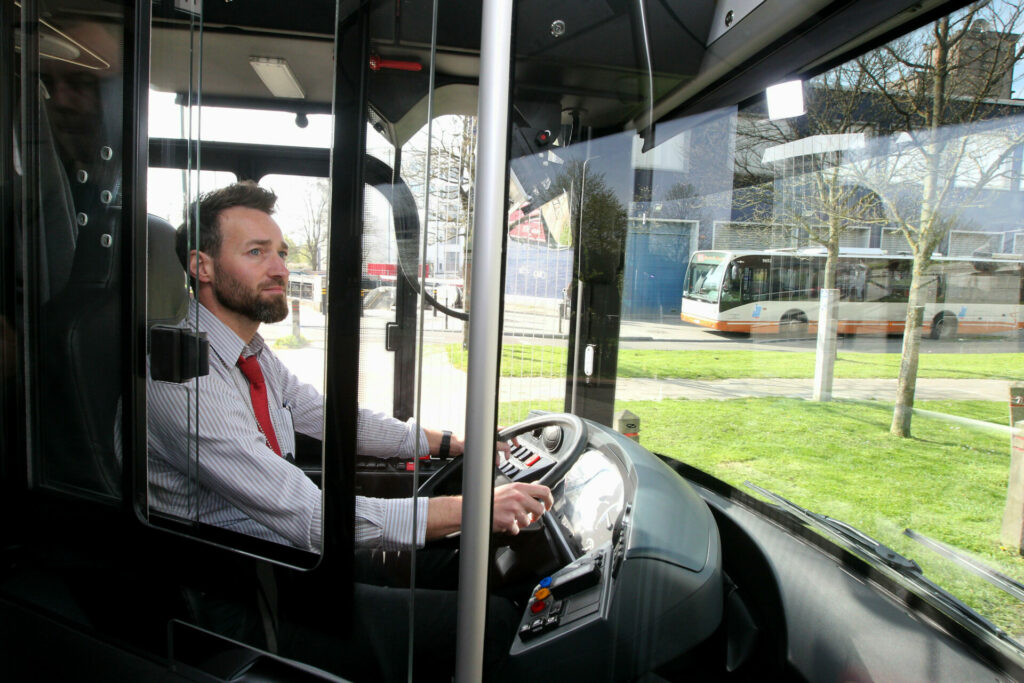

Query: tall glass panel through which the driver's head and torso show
[146,1,334,563]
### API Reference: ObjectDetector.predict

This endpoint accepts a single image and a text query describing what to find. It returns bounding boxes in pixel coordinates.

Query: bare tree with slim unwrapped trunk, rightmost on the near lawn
[857,2,1022,436]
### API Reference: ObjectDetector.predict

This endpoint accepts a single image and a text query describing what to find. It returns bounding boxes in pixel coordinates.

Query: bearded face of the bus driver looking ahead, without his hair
[211,207,288,323]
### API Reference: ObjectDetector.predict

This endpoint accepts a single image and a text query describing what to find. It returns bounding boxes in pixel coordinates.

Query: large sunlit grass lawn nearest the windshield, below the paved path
[502,398,1024,633]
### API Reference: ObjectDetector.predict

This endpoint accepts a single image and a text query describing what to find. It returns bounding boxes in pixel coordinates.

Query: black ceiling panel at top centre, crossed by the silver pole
[370,0,714,137]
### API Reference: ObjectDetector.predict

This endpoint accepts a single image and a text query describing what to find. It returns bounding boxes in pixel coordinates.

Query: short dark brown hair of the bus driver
[175,180,278,280]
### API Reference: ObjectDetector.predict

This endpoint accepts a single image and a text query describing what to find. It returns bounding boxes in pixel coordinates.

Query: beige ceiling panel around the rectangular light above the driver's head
[150,27,334,111]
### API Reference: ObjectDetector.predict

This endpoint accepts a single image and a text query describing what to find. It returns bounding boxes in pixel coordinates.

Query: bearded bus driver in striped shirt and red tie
[147,181,552,680]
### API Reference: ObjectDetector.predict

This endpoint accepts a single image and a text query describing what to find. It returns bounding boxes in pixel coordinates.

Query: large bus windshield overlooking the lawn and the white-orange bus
[500,1,1024,647]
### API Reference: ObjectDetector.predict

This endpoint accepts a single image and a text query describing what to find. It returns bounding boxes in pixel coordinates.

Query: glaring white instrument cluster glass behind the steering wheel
[553,451,626,553]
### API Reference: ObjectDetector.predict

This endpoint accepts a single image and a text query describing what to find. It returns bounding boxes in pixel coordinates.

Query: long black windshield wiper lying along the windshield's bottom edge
[743,481,1024,651]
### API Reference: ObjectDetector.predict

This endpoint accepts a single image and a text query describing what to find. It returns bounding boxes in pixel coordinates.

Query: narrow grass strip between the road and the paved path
[447,344,1024,381]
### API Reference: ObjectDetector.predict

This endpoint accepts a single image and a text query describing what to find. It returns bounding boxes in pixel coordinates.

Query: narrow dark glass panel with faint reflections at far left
[17,2,130,501]
